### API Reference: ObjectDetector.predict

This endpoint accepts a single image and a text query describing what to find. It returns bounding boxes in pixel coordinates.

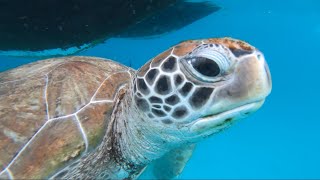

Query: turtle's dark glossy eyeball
[188,57,221,77]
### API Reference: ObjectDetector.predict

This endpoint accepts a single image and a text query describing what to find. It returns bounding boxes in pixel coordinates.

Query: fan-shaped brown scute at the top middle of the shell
[47,62,111,118]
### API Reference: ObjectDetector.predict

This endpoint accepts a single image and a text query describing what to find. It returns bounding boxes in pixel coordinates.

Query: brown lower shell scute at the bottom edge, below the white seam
[10,117,85,179]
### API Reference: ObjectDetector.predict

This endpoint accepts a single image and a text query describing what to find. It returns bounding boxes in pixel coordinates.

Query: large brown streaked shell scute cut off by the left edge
[0,78,47,171]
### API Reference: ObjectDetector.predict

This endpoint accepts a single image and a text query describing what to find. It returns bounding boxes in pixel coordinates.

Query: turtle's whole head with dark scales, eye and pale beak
[134,38,271,139]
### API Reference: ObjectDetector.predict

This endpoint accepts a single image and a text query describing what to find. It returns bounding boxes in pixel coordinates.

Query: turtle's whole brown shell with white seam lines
[0,56,134,179]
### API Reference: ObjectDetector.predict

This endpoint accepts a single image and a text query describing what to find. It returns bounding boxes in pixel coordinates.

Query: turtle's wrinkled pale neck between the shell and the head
[107,82,181,177]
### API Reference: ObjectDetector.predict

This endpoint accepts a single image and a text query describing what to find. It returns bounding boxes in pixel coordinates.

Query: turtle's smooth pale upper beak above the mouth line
[213,51,272,107]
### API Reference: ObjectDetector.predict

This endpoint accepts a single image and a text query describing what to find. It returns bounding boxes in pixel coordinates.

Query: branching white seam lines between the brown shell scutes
[0,69,131,179]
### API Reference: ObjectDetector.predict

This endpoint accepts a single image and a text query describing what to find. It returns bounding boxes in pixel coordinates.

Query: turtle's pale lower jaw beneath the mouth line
[190,99,264,134]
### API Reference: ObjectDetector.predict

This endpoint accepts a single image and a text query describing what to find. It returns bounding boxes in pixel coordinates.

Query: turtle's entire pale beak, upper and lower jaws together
[191,51,272,134]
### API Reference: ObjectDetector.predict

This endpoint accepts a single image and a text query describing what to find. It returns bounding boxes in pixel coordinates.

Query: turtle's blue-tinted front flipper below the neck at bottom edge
[140,144,195,179]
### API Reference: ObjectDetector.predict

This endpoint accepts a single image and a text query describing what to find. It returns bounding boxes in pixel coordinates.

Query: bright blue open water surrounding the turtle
[0,0,320,179]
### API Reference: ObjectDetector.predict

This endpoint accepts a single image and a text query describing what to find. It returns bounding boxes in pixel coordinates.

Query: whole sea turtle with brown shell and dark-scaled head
[0,38,271,179]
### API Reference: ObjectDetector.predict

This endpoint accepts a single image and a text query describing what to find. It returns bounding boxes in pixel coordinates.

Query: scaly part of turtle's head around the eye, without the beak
[134,38,270,129]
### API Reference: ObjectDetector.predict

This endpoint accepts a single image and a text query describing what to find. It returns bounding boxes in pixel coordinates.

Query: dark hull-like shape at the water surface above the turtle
[0,0,219,56]
